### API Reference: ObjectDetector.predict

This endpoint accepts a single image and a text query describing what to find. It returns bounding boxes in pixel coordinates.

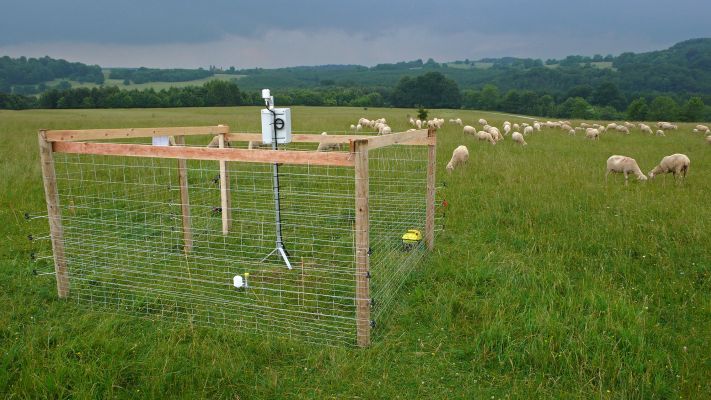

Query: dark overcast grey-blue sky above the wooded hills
[0,0,711,68]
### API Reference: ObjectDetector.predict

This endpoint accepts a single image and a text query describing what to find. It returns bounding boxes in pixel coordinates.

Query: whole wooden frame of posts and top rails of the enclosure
[38,125,437,347]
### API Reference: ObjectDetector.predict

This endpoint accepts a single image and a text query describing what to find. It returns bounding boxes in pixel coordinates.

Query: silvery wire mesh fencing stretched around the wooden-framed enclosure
[46,130,428,345]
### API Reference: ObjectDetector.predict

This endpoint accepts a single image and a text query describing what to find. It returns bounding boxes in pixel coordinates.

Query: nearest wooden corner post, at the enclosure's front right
[354,140,370,347]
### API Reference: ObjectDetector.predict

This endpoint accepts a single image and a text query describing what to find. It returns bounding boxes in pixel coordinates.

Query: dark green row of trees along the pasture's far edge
[0,72,711,121]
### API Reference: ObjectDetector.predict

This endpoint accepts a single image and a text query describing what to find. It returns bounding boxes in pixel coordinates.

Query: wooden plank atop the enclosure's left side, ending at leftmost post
[46,125,230,142]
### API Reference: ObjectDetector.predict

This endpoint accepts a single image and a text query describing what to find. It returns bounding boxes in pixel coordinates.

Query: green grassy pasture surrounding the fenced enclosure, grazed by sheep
[0,107,711,399]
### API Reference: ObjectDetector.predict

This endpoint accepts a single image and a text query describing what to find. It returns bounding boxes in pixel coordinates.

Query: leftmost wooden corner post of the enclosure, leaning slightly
[38,130,69,299]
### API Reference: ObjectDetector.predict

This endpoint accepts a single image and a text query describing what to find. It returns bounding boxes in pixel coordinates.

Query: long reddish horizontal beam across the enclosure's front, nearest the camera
[52,142,355,167]
